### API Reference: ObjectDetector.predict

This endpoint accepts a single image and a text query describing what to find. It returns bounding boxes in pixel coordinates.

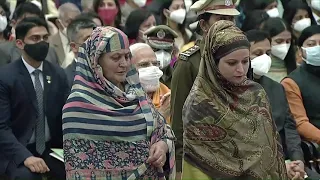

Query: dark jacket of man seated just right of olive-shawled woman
[259,76,304,161]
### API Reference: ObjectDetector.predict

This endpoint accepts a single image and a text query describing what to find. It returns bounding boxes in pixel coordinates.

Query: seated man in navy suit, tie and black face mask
[0,17,69,180]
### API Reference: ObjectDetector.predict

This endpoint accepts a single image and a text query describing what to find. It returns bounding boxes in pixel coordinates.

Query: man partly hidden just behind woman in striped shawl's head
[65,17,96,88]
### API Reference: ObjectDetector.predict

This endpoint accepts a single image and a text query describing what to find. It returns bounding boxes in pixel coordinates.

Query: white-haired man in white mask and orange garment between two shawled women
[130,43,170,124]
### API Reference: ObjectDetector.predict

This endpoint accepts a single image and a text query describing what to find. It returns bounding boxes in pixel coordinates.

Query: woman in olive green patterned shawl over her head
[183,21,287,180]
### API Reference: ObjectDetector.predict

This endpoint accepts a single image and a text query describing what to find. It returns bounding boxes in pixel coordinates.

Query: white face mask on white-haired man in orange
[138,66,163,93]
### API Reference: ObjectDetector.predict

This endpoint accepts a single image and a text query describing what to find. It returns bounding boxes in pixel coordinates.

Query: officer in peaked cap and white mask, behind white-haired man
[144,25,178,88]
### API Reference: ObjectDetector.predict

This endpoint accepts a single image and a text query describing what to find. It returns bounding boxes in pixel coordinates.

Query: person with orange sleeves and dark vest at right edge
[281,25,320,144]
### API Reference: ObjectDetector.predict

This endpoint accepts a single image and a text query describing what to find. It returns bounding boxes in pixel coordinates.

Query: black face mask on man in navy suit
[24,41,49,61]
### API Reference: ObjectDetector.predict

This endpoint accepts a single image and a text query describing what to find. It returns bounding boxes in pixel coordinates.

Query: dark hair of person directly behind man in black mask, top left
[12,2,45,20]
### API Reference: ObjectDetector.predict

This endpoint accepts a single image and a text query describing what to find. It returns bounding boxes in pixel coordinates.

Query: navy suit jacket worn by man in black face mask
[0,58,69,174]
